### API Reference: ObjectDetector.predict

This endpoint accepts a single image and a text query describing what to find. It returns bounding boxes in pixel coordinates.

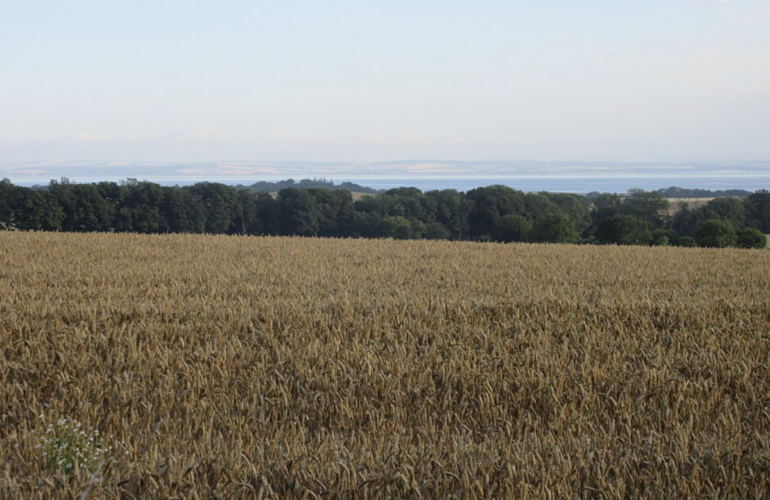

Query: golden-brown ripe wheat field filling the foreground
[0,233,770,499]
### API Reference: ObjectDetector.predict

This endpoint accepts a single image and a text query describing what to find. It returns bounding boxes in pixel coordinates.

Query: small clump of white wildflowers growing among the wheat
[37,418,111,475]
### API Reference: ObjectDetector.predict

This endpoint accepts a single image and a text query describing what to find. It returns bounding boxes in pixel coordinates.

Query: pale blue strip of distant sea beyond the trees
[14,175,770,194]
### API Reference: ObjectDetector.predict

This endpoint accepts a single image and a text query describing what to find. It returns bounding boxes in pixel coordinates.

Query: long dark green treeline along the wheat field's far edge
[0,179,770,247]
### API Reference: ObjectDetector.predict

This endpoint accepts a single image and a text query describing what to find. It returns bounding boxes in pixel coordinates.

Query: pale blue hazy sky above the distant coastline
[0,0,770,162]
